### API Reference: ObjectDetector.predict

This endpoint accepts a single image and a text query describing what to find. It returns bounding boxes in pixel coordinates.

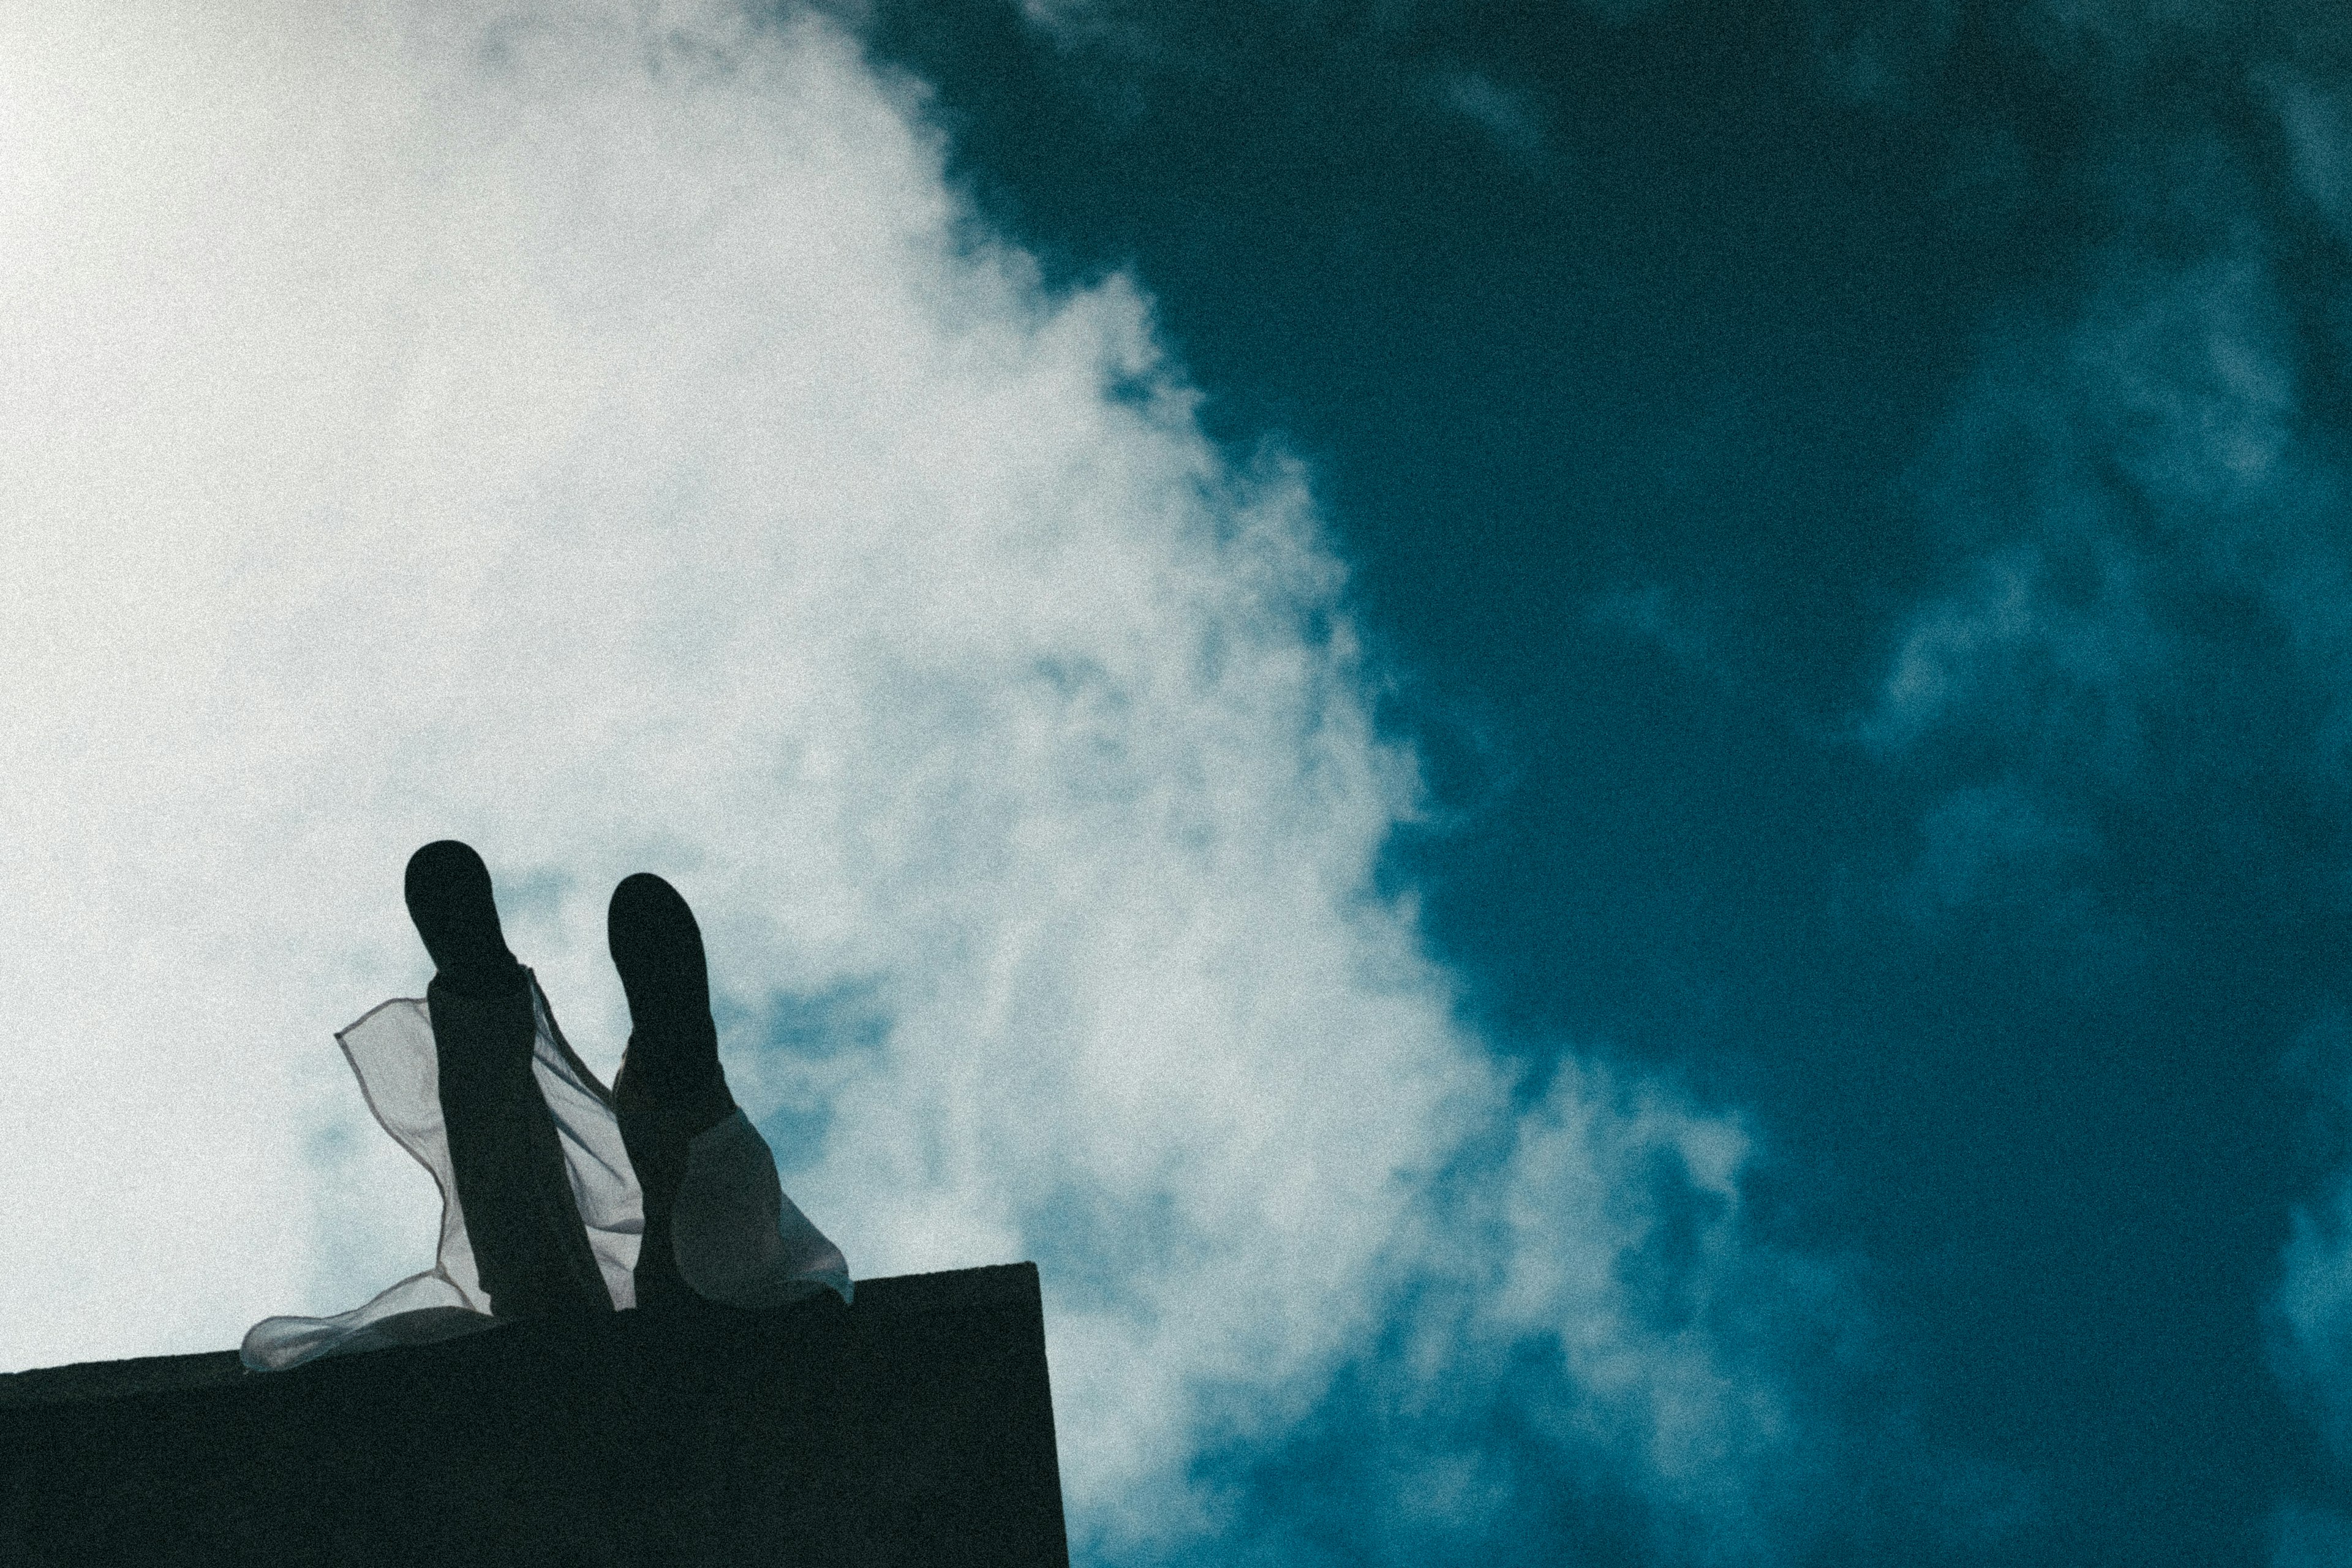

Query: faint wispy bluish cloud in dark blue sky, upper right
[1858,254,2323,778]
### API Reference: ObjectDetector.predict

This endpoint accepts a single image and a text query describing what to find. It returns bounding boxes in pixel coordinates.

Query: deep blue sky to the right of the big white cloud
[851,2,2352,1563]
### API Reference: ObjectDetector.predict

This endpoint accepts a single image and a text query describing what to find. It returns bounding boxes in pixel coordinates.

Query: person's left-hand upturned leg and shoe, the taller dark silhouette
[407,839,611,1316]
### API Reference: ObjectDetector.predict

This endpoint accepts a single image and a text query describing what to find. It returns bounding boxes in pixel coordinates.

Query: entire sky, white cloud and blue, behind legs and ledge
[0,0,2352,1568]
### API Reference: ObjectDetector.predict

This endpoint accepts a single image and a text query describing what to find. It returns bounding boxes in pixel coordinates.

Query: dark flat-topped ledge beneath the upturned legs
[0,1262,1068,1568]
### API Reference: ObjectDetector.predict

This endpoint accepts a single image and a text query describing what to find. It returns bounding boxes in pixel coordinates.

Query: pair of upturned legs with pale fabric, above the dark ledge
[240,839,856,1371]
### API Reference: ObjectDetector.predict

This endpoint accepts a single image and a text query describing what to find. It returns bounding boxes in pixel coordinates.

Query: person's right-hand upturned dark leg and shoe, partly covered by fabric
[605,872,736,1307]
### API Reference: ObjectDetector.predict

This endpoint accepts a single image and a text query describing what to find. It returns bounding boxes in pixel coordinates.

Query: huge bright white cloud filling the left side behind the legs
[0,0,1853,1551]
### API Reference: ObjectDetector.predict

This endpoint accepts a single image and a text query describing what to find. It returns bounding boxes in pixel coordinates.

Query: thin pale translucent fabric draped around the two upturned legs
[238,976,851,1371]
